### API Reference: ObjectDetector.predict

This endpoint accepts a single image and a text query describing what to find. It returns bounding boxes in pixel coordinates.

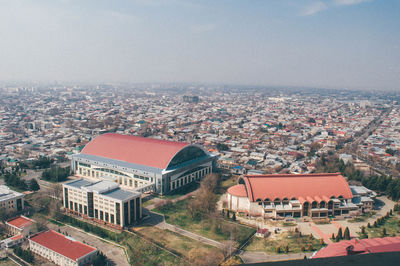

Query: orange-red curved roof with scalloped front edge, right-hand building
[234,173,353,203]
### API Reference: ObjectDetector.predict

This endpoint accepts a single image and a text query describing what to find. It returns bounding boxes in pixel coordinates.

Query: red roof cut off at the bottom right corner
[313,236,400,258]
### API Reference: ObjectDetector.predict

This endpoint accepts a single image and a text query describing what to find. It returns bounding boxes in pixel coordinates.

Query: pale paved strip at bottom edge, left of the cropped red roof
[239,251,313,264]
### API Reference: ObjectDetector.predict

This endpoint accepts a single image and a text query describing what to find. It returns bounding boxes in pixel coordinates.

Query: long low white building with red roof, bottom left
[29,230,98,265]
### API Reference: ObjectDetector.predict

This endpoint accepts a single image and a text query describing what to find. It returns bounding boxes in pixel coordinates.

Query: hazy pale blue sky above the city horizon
[0,0,400,90]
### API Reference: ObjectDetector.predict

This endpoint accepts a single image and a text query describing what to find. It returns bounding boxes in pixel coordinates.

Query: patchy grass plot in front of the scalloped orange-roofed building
[245,232,322,254]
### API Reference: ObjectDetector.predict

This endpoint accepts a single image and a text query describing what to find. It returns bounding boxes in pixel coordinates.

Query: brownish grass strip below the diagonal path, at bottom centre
[135,226,222,259]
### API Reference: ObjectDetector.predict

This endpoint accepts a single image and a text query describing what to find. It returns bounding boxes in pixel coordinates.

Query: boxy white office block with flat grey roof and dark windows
[63,179,142,229]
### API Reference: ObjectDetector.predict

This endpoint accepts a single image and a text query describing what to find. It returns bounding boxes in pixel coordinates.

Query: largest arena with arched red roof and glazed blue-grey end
[71,133,218,194]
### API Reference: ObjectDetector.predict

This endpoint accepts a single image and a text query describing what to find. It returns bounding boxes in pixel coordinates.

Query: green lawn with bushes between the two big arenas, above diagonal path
[154,198,256,245]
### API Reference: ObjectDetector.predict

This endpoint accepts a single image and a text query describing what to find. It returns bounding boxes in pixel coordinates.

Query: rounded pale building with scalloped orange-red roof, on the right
[226,173,373,218]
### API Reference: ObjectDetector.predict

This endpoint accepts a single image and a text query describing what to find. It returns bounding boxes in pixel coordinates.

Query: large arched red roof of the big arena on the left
[82,133,190,169]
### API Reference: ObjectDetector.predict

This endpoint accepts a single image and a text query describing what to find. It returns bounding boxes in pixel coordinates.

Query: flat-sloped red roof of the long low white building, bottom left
[30,230,97,261]
